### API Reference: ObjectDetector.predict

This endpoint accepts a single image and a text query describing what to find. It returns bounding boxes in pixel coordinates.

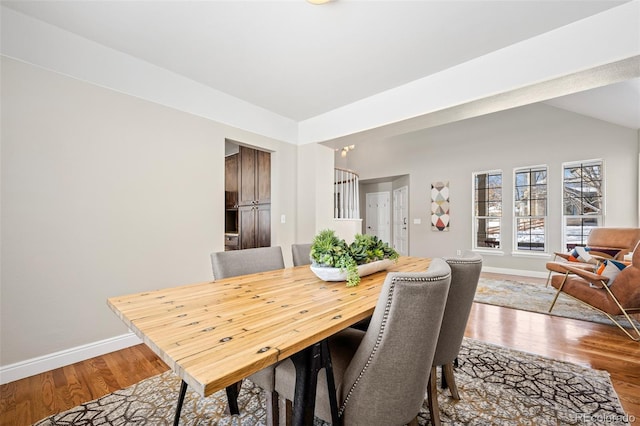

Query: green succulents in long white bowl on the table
[309,229,399,287]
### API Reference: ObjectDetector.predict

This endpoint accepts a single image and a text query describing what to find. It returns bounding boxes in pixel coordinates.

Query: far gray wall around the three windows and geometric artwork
[343,104,639,272]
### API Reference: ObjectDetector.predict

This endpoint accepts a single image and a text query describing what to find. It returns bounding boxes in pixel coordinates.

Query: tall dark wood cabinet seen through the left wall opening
[225,146,271,250]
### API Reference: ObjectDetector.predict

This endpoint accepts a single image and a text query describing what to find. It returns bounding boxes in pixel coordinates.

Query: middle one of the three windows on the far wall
[513,166,547,252]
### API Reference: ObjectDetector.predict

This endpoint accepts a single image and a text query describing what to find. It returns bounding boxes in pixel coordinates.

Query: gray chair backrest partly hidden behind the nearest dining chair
[433,251,482,365]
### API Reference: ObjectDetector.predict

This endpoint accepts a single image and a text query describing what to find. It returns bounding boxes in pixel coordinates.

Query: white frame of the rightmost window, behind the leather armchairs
[560,158,606,248]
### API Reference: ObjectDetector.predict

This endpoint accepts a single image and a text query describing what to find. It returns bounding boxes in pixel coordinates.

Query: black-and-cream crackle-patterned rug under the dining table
[36,339,629,426]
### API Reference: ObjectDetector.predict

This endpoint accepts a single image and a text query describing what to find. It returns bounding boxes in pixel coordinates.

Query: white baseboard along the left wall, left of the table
[0,333,142,385]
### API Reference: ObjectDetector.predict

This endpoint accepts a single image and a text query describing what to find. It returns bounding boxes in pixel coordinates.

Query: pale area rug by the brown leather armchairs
[474,277,640,328]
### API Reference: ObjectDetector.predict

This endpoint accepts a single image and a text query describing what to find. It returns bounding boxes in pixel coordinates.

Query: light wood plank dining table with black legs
[107,256,430,425]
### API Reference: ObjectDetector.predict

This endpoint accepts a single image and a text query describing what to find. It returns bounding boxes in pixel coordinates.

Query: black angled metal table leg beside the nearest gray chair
[291,339,340,426]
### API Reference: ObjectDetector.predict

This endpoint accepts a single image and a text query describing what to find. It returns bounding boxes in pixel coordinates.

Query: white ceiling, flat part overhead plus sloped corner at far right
[2,0,640,128]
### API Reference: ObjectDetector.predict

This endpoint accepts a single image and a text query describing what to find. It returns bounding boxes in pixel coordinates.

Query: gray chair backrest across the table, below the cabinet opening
[211,247,284,280]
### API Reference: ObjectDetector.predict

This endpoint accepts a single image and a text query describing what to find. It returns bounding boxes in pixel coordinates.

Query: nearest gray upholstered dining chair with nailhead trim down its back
[276,259,451,426]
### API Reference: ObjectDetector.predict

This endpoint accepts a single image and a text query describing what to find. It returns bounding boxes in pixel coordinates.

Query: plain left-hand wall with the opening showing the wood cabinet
[0,58,297,366]
